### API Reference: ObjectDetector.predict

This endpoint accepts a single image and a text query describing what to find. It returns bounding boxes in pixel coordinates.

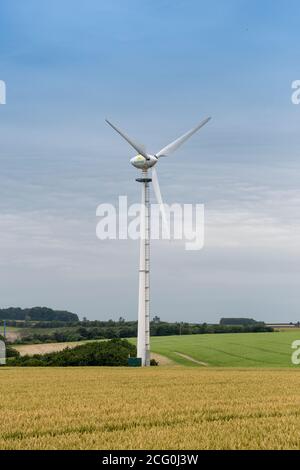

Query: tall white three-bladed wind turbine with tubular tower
[106,117,211,366]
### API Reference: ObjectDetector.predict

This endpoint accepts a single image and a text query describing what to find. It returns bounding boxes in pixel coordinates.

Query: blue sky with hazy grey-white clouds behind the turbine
[0,0,300,321]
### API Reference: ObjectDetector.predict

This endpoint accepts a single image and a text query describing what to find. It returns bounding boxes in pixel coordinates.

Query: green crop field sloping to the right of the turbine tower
[151,330,300,367]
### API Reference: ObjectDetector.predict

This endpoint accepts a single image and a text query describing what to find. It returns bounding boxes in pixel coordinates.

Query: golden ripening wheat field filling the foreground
[0,366,300,449]
